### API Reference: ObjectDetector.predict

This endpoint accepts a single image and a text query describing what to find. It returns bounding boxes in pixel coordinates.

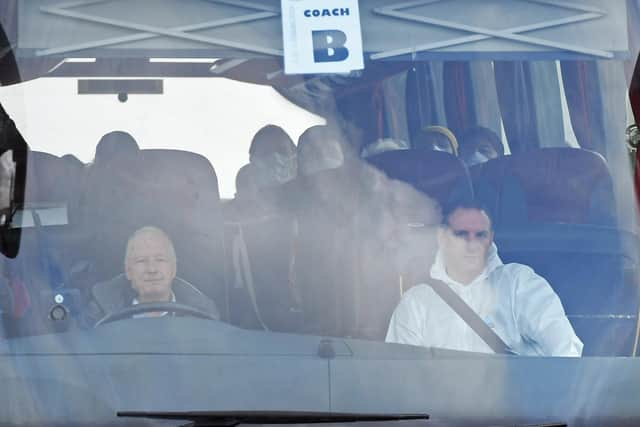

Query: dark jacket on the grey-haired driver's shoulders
[85,274,220,325]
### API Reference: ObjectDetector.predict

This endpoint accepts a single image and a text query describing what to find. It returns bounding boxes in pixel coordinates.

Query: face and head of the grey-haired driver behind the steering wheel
[126,232,176,302]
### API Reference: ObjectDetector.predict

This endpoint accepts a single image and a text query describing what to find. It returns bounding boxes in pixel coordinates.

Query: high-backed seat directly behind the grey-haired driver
[80,149,225,316]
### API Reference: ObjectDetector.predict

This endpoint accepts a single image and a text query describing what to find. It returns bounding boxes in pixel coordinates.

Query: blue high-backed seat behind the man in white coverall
[471,148,639,356]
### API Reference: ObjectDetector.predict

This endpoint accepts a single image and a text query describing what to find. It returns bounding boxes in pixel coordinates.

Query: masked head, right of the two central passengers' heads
[298,126,344,176]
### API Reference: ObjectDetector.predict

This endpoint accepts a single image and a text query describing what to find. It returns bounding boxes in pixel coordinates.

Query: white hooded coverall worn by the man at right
[386,244,583,357]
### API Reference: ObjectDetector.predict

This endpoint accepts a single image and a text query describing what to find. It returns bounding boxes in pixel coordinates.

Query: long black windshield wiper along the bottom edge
[118,411,429,427]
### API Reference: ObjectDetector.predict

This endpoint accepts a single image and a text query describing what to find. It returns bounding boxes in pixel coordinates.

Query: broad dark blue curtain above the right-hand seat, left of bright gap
[494,61,566,153]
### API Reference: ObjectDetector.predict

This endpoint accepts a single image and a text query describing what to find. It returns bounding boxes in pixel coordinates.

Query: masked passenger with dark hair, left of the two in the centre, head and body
[230,125,301,332]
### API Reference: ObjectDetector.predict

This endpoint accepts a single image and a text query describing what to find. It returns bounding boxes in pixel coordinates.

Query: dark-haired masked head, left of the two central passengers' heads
[249,125,297,189]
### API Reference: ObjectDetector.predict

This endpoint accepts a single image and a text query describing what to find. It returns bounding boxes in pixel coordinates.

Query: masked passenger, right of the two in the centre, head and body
[292,126,361,336]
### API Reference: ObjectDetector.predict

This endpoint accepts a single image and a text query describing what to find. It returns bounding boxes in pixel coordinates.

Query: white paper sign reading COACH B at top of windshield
[282,0,364,74]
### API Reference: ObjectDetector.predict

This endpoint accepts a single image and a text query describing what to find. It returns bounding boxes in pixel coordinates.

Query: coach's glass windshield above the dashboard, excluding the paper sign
[0,1,638,356]
